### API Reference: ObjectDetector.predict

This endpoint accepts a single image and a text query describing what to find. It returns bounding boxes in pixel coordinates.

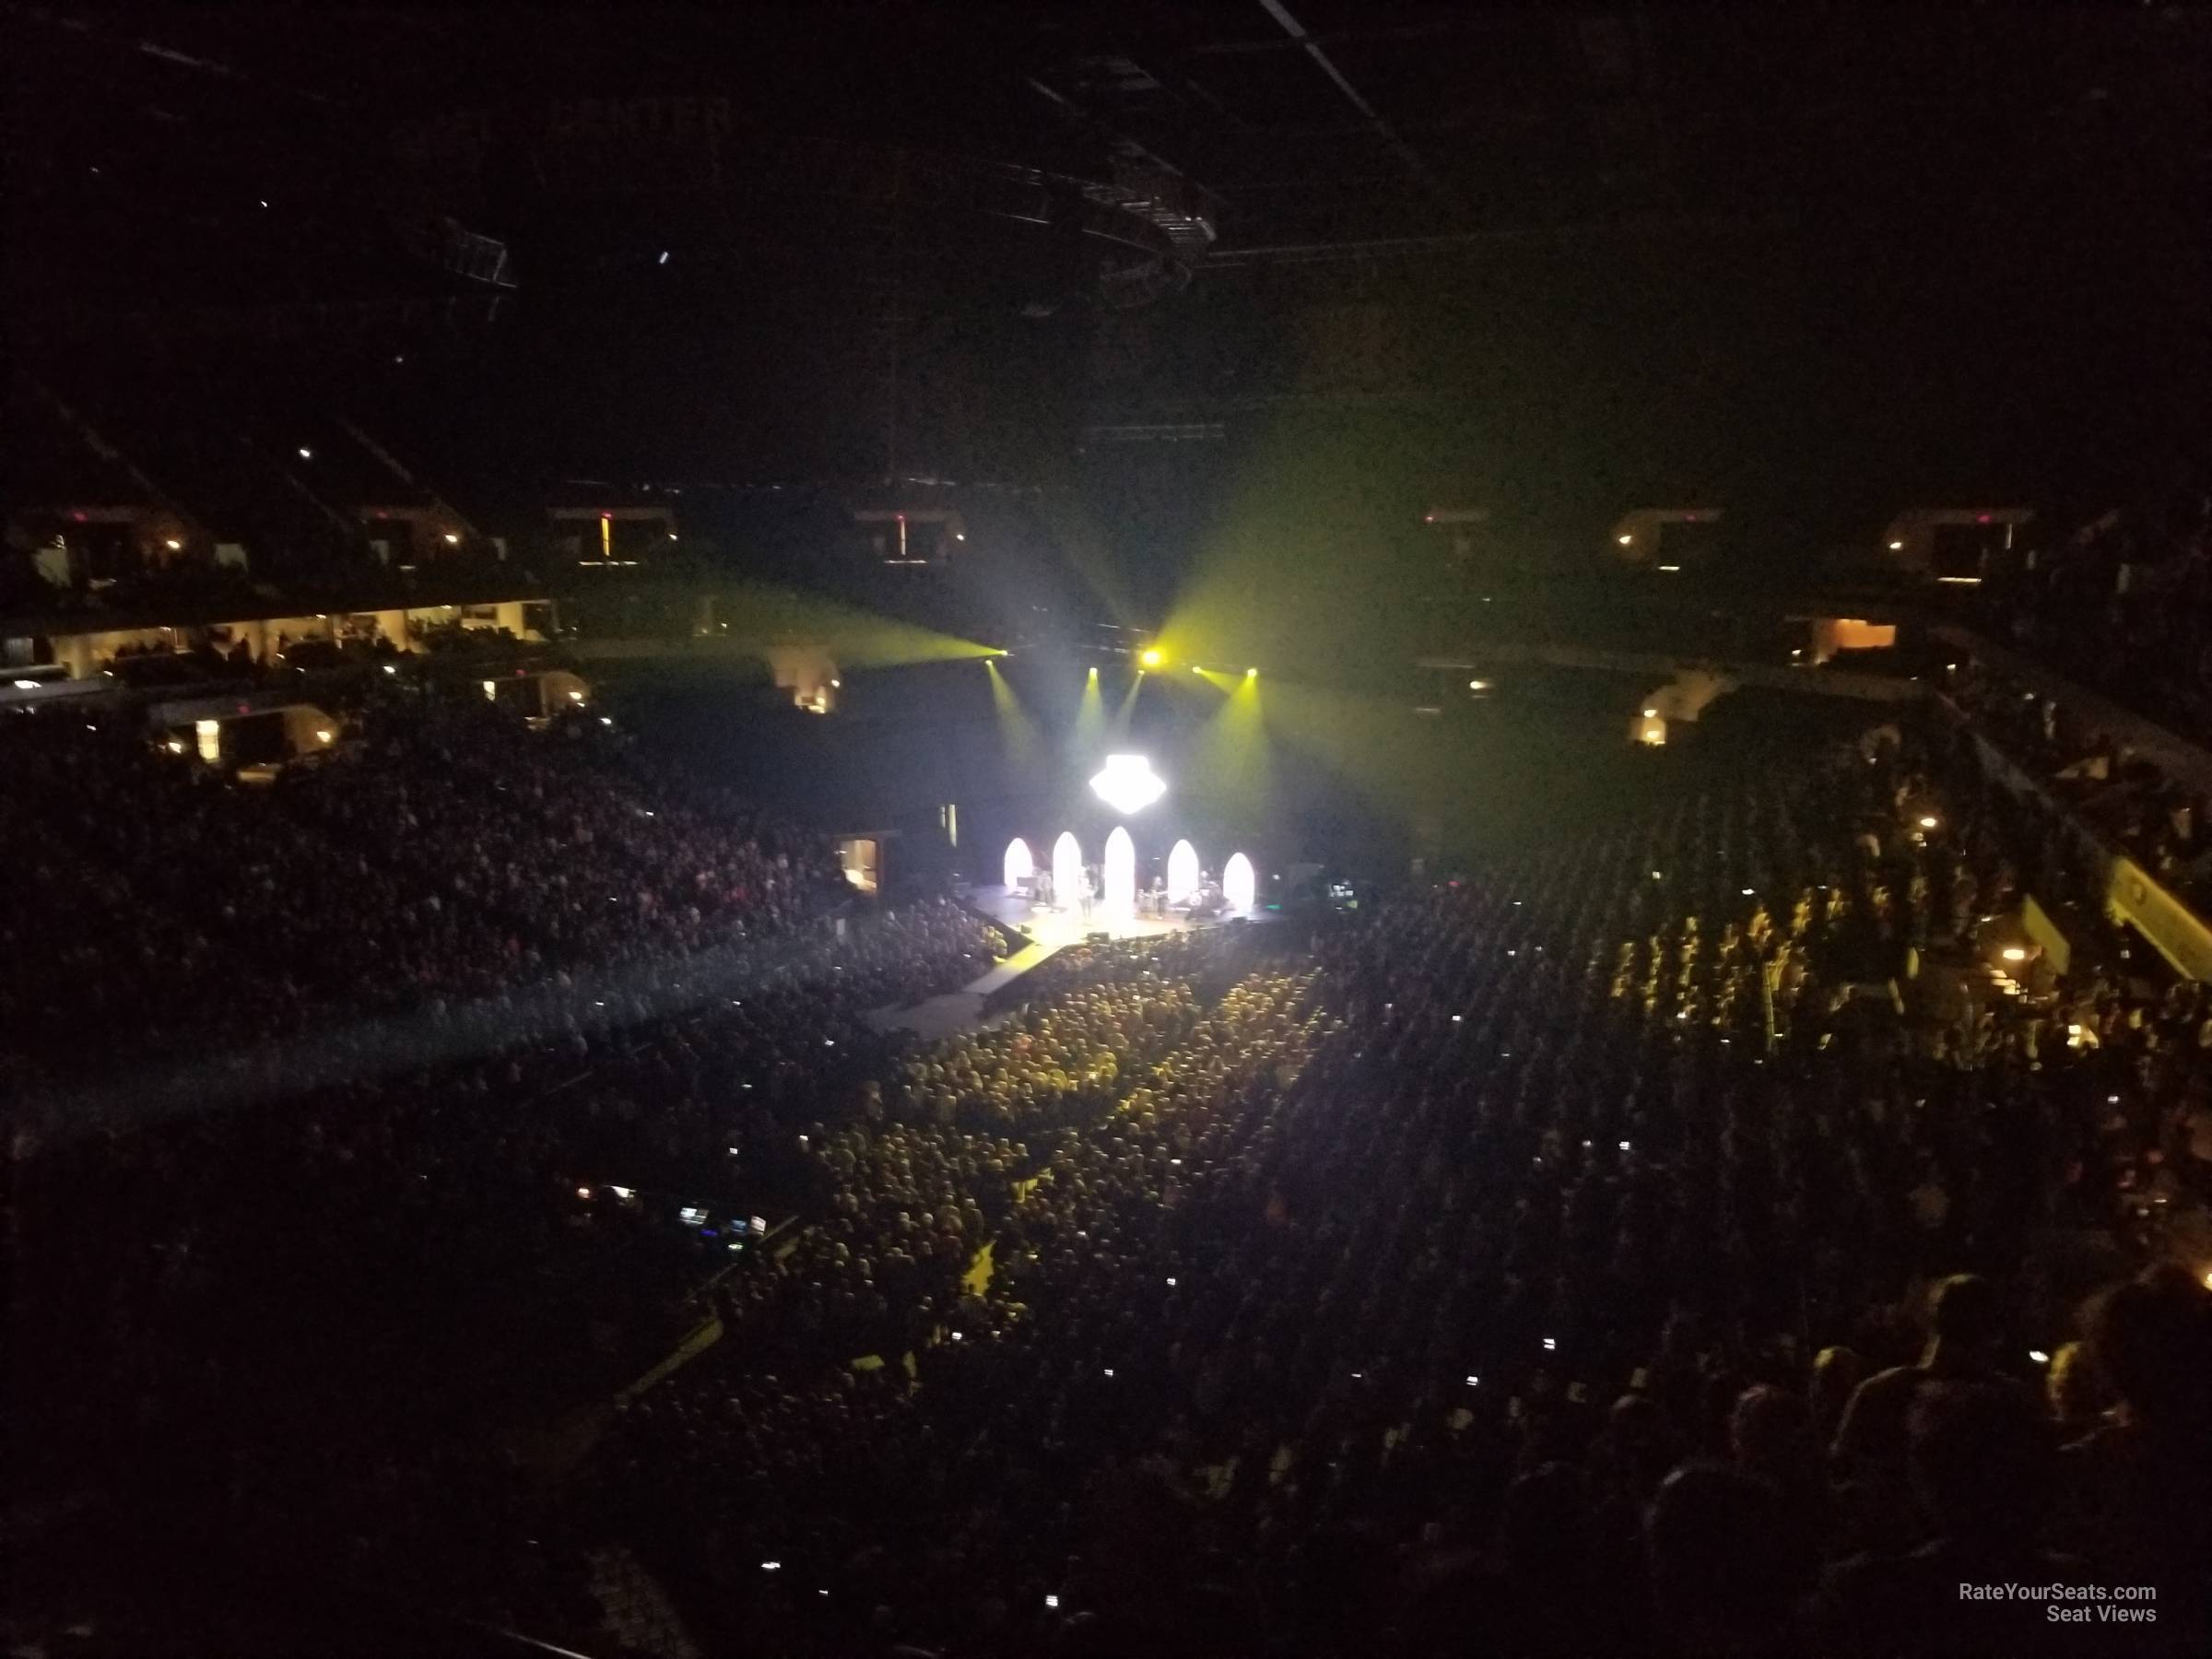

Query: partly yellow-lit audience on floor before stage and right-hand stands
[561,716,2212,1654]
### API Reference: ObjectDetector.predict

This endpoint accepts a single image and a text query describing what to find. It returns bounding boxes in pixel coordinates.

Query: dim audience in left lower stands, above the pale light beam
[0,699,871,1106]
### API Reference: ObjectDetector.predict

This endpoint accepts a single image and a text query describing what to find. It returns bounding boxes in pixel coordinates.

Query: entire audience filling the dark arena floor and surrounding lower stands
[0,689,2212,1657]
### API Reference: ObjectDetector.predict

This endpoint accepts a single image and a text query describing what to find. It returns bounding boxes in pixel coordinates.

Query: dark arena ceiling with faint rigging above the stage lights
[0,0,2207,493]
